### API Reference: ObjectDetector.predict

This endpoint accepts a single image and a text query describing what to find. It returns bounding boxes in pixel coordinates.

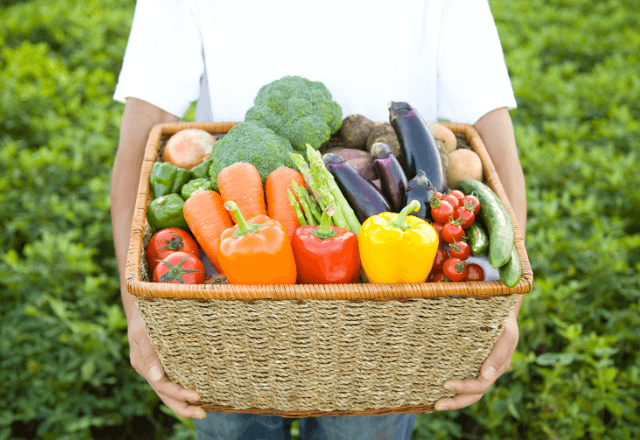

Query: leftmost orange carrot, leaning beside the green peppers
[182,189,233,273]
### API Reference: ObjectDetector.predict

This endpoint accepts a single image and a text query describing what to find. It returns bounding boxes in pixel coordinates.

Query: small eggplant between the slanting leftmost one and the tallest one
[371,142,408,212]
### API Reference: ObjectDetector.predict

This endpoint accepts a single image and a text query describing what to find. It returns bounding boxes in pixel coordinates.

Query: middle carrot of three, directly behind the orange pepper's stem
[218,162,267,223]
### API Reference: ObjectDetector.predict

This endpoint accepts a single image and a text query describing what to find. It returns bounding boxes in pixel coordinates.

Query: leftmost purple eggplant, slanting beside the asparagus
[322,153,391,223]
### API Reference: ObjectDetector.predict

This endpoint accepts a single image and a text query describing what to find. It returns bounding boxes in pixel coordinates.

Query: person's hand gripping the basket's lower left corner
[128,310,207,419]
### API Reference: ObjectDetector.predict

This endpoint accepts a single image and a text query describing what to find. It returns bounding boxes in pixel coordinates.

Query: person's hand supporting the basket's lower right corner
[435,310,520,411]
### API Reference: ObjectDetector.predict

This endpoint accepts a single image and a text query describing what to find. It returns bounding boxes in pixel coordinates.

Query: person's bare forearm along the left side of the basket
[111,98,179,322]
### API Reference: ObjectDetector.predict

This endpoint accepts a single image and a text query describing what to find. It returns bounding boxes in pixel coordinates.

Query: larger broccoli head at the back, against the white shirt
[244,76,342,151]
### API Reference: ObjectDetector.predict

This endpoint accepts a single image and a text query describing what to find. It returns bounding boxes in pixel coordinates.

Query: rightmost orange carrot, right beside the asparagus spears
[265,167,305,239]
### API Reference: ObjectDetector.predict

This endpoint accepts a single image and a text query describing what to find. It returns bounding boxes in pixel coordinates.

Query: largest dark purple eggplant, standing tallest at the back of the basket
[389,101,447,194]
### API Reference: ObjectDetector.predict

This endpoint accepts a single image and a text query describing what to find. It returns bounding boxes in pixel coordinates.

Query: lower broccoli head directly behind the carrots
[209,122,294,191]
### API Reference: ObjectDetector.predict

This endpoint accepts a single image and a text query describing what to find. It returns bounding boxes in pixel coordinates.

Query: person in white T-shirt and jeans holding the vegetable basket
[111,0,526,440]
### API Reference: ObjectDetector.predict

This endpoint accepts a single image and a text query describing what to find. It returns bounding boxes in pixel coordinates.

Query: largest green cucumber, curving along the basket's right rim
[458,179,515,268]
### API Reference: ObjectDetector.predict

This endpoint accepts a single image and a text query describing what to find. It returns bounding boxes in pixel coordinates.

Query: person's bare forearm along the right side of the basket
[475,107,527,316]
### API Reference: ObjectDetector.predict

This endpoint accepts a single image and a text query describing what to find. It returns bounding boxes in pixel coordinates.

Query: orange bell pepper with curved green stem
[217,201,297,284]
